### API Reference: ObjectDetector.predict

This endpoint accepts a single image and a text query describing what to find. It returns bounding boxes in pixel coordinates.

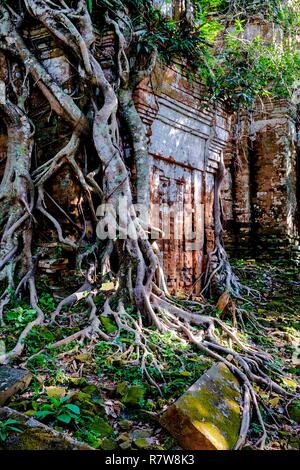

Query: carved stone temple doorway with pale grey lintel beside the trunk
[136,64,230,290]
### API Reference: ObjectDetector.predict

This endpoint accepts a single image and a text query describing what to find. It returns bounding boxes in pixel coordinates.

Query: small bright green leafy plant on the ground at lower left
[35,396,80,424]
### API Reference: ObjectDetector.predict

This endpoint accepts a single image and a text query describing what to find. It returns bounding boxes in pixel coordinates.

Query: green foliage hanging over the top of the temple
[123,0,300,108]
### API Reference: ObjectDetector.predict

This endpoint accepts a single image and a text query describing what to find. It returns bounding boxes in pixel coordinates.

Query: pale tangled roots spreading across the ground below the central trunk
[7,286,292,449]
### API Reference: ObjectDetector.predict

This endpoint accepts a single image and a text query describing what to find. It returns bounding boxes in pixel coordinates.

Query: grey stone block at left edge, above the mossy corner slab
[0,366,32,406]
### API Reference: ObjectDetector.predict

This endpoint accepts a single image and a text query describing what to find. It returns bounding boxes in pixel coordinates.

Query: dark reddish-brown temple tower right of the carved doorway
[223,17,300,261]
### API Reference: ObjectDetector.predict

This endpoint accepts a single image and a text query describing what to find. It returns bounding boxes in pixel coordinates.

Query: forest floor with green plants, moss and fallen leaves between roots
[0,260,300,450]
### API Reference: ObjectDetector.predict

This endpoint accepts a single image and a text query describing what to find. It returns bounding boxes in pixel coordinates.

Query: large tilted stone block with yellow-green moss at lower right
[160,364,241,450]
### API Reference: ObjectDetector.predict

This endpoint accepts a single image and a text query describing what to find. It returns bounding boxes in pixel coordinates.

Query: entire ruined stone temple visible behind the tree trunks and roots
[0,2,300,291]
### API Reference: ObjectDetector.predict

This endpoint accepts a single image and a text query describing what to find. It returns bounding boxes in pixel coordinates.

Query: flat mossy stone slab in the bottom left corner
[0,407,93,450]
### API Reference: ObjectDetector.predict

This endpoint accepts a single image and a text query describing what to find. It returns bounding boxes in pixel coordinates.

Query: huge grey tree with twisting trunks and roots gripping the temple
[0,0,294,448]
